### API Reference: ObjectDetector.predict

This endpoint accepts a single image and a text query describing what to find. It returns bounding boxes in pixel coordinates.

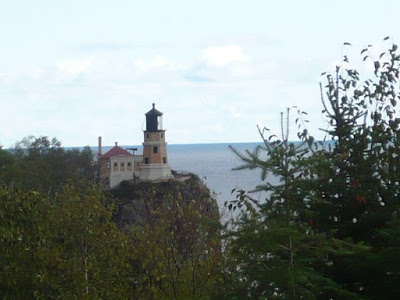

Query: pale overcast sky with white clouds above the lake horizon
[0,0,400,147]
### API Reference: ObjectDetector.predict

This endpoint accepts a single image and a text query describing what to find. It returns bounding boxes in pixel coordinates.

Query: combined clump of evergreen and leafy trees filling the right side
[229,39,400,299]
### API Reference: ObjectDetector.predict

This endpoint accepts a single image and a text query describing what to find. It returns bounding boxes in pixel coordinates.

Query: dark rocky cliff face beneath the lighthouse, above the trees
[110,175,219,226]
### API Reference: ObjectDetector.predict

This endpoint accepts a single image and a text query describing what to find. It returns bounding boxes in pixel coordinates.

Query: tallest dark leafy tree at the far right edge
[312,39,400,299]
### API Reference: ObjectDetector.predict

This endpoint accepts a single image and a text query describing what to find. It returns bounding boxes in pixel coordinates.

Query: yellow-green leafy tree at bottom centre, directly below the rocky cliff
[130,189,222,299]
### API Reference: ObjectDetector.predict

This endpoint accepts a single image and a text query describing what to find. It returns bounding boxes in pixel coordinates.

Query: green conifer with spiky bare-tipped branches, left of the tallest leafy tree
[229,110,360,299]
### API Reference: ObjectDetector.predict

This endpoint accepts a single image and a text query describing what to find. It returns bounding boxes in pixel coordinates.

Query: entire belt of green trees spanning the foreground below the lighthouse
[0,39,400,299]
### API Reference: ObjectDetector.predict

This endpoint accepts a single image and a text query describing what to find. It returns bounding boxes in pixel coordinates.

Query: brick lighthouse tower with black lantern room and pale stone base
[140,103,173,181]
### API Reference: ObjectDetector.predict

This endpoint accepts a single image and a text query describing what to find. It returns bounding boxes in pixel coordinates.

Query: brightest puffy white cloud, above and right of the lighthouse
[202,45,249,67]
